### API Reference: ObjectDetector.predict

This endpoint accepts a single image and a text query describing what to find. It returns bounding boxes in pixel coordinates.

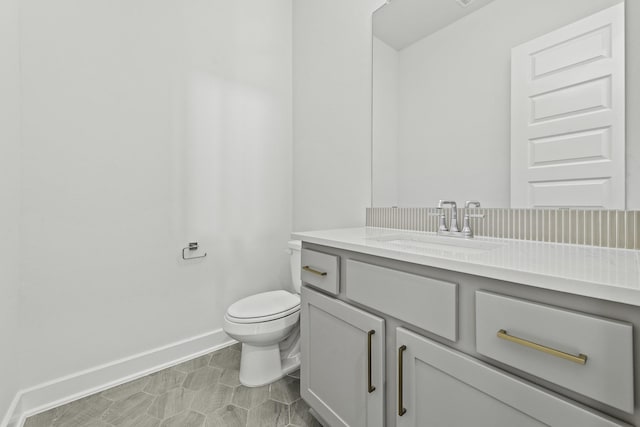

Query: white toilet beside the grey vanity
[224,240,301,387]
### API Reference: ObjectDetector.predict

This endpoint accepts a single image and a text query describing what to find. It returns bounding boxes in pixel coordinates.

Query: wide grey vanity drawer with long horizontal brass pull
[476,291,634,413]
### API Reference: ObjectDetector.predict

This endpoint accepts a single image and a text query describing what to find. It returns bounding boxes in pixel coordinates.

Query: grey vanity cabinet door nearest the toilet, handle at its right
[300,286,385,427]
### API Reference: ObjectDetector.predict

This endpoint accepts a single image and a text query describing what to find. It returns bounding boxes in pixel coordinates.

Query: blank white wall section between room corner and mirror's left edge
[293,0,383,231]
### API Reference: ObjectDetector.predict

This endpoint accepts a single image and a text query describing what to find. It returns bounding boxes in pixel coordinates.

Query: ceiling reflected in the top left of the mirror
[373,0,493,50]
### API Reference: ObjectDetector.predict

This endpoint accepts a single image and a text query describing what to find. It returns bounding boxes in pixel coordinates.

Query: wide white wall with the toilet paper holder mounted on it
[18,0,292,387]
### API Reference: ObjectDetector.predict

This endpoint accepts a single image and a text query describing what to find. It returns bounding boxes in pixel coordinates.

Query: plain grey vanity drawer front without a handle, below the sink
[346,260,458,341]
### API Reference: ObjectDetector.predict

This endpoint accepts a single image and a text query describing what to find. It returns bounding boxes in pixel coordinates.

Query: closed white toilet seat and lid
[225,290,300,323]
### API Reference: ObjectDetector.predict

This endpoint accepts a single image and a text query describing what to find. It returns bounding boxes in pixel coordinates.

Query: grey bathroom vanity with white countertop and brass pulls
[294,227,640,427]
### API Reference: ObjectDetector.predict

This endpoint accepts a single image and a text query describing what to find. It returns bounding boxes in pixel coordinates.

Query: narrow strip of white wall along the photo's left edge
[0,0,21,424]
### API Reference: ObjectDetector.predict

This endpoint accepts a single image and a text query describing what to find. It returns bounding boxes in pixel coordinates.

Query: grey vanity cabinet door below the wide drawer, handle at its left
[392,328,627,427]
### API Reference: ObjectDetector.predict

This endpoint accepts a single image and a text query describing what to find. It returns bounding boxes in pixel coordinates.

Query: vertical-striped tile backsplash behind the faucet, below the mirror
[366,208,640,249]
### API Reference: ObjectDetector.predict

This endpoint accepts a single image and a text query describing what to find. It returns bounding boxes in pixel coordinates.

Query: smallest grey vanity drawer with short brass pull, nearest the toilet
[300,249,340,295]
